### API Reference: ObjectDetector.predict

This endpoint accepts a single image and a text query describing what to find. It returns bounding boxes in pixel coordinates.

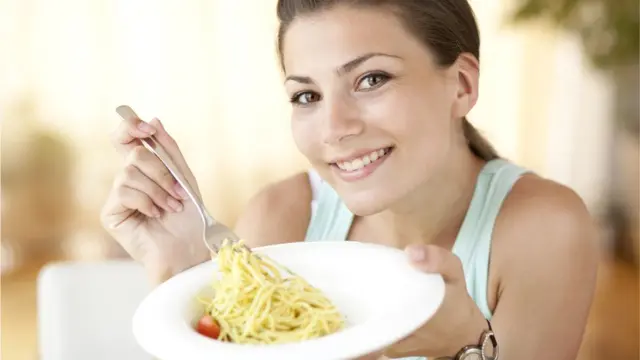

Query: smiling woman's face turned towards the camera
[283,7,462,215]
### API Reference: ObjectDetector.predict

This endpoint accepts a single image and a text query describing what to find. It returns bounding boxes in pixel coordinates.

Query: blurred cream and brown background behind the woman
[0,0,640,360]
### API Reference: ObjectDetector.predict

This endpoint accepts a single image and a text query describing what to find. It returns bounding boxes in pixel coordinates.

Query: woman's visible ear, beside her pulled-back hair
[453,53,480,118]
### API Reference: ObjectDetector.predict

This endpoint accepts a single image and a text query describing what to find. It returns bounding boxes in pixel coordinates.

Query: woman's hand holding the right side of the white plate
[360,245,488,358]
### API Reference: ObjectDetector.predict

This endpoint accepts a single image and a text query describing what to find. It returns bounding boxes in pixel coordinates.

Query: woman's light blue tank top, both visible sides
[305,159,528,360]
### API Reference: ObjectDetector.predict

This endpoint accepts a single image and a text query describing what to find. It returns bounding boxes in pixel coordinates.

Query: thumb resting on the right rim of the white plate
[405,244,464,283]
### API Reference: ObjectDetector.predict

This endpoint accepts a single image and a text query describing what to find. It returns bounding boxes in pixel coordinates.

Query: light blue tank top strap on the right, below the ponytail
[453,159,528,319]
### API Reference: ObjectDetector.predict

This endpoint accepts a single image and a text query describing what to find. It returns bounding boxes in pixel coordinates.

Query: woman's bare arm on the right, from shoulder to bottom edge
[492,176,597,360]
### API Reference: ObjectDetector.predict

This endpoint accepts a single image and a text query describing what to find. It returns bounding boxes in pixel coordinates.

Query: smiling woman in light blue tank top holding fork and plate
[102,0,596,360]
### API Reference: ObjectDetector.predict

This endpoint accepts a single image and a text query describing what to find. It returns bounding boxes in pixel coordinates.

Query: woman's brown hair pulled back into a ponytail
[277,0,499,161]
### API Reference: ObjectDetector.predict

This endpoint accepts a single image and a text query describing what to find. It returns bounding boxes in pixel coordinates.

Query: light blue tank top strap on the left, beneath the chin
[304,171,353,241]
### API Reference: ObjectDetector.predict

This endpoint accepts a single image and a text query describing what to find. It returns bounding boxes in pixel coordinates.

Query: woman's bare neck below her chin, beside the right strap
[375,151,485,248]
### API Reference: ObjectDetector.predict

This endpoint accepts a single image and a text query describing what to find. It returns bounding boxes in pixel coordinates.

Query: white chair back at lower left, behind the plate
[38,261,152,360]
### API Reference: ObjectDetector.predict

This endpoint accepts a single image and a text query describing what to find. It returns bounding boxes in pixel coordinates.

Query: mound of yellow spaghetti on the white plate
[199,241,344,344]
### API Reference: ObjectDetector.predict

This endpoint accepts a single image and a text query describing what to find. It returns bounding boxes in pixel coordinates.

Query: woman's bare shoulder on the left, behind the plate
[235,172,312,247]
